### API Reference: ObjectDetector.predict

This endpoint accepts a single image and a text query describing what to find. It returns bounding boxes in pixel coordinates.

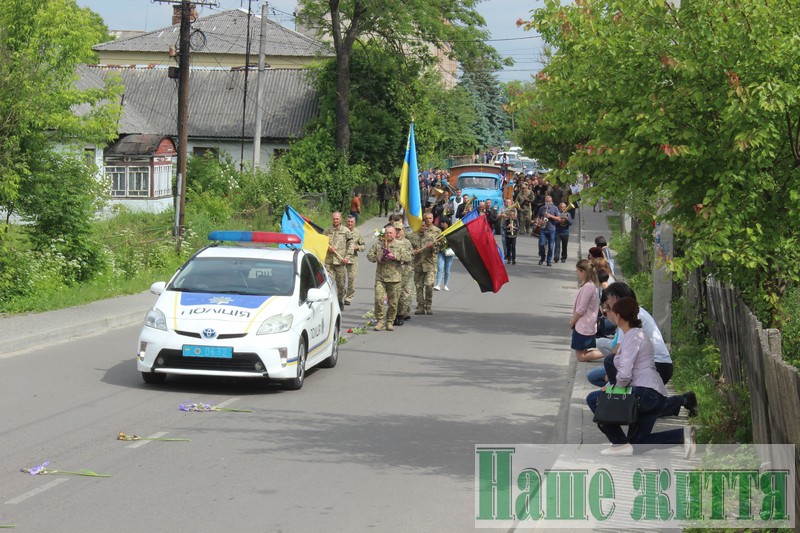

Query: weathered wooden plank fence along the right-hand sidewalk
[689,277,800,517]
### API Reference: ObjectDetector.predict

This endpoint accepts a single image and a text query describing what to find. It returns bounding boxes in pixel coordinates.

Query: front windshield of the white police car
[167,257,295,296]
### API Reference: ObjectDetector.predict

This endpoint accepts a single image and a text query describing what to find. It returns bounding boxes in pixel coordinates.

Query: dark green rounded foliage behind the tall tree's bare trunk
[294,41,478,181]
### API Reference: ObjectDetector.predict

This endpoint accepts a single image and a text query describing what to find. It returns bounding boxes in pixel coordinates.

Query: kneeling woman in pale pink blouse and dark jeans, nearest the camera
[586,298,695,457]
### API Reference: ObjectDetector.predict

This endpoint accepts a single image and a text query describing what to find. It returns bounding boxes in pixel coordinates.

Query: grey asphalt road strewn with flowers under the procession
[0,227,576,532]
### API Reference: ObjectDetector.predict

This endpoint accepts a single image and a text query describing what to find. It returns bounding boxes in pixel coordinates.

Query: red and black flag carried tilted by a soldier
[442,216,508,292]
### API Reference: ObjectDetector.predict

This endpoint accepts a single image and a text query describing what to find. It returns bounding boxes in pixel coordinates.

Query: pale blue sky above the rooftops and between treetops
[77,0,542,82]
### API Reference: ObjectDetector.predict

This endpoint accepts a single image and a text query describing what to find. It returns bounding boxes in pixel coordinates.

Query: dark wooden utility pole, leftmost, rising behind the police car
[156,0,218,252]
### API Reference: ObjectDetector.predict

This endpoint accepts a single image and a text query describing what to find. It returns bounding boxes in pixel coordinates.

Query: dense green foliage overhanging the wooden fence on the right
[518,0,800,324]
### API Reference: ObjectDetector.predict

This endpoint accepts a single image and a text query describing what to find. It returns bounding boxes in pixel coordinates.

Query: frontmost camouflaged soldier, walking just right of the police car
[367,224,411,331]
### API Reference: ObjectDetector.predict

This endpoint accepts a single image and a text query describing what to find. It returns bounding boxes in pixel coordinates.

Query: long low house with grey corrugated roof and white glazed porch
[77,65,319,212]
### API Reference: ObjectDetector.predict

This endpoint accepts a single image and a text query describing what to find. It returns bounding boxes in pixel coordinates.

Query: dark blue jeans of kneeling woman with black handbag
[586,387,683,444]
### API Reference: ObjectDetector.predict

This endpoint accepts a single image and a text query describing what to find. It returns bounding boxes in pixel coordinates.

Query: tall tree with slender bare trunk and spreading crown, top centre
[299,0,499,153]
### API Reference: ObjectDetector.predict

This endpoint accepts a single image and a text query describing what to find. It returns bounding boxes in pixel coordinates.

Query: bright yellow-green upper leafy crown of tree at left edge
[0,0,121,218]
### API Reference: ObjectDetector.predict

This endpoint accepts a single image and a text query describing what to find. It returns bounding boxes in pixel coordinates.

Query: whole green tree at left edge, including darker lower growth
[0,0,120,283]
